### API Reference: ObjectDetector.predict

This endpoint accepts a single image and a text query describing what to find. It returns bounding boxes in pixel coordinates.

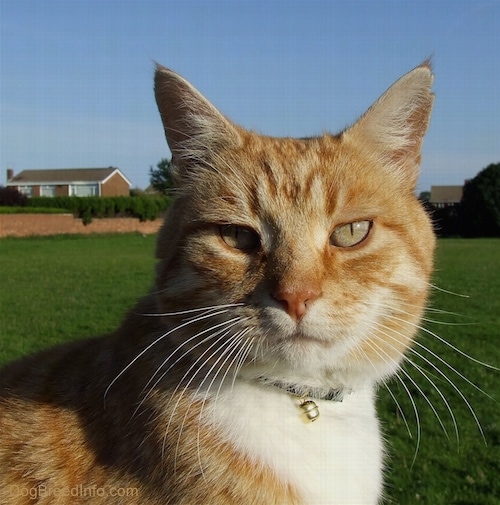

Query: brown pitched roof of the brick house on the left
[7,167,132,186]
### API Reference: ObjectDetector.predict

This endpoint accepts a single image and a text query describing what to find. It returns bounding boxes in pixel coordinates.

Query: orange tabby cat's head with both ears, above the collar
[155,62,435,387]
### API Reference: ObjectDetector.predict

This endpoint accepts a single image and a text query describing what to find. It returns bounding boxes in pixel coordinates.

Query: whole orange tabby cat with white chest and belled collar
[0,63,434,505]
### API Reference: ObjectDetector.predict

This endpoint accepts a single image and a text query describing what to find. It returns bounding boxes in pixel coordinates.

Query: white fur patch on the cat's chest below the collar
[201,382,383,505]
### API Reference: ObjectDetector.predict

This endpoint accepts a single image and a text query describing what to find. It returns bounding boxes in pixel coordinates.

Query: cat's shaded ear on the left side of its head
[155,64,240,164]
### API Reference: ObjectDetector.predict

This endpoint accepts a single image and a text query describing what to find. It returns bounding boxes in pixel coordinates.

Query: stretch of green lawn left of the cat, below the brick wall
[0,234,156,362]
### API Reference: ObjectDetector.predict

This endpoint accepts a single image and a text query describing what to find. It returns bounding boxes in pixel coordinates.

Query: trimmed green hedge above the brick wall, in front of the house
[27,196,172,224]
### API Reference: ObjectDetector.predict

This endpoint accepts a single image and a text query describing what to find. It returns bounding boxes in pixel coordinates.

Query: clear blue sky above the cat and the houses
[0,0,500,191]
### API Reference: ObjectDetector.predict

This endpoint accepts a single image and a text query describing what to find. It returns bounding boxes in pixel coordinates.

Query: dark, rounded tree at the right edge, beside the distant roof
[460,163,500,237]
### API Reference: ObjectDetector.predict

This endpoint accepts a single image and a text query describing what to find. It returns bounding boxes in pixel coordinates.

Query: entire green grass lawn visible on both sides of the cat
[0,235,500,505]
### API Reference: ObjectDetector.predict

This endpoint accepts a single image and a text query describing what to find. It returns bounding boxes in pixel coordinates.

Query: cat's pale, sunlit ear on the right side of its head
[343,61,434,190]
